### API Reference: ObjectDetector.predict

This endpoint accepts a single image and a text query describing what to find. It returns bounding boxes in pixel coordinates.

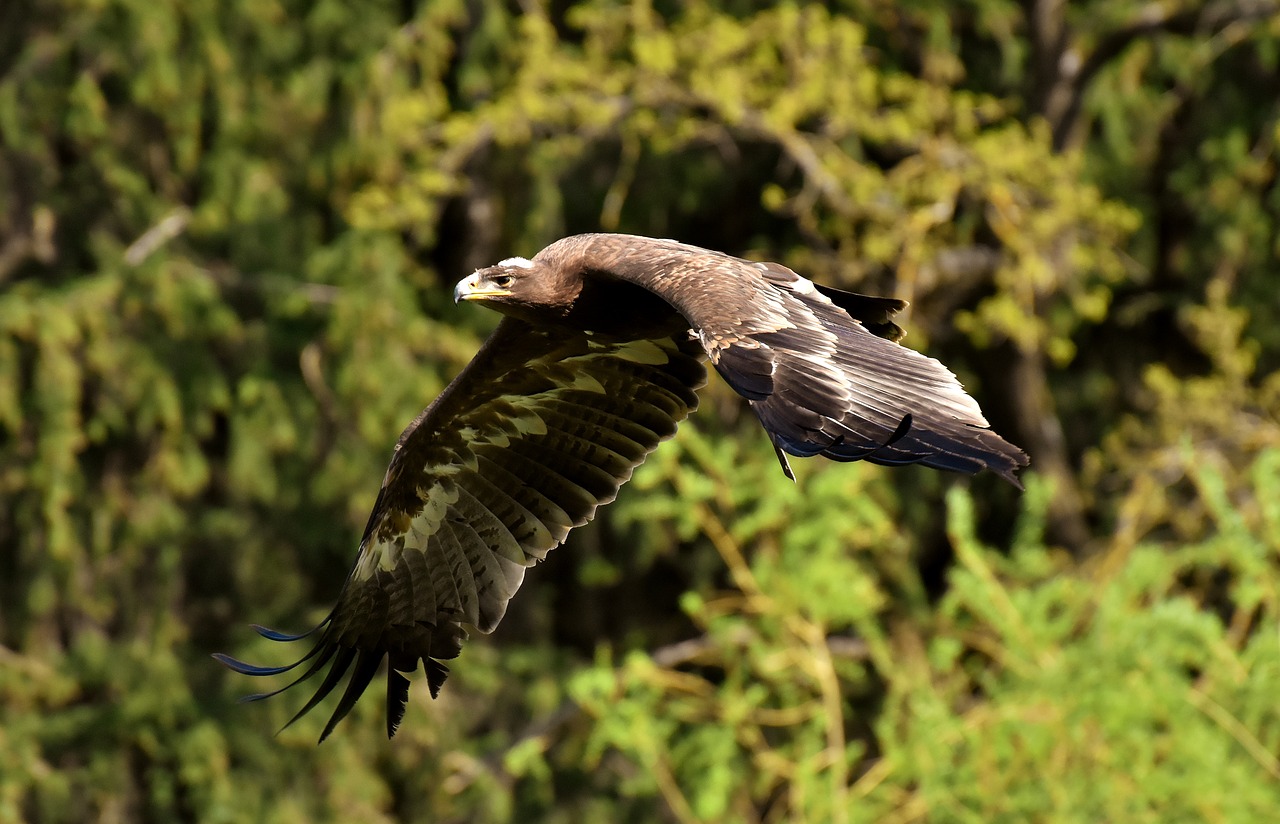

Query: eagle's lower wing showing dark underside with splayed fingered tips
[219,319,705,741]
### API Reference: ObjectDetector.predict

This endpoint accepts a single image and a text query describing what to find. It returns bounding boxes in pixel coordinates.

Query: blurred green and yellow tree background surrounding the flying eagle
[0,0,1280,824]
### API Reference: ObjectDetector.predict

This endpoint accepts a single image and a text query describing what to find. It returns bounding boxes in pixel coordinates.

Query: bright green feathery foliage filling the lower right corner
[572,450,1280,821]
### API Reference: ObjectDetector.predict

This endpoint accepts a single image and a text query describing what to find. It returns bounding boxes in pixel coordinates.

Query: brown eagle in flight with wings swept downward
[216,234,1028,741]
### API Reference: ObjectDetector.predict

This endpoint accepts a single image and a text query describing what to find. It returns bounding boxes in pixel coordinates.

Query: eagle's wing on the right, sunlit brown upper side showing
[599,241,1028,486]
